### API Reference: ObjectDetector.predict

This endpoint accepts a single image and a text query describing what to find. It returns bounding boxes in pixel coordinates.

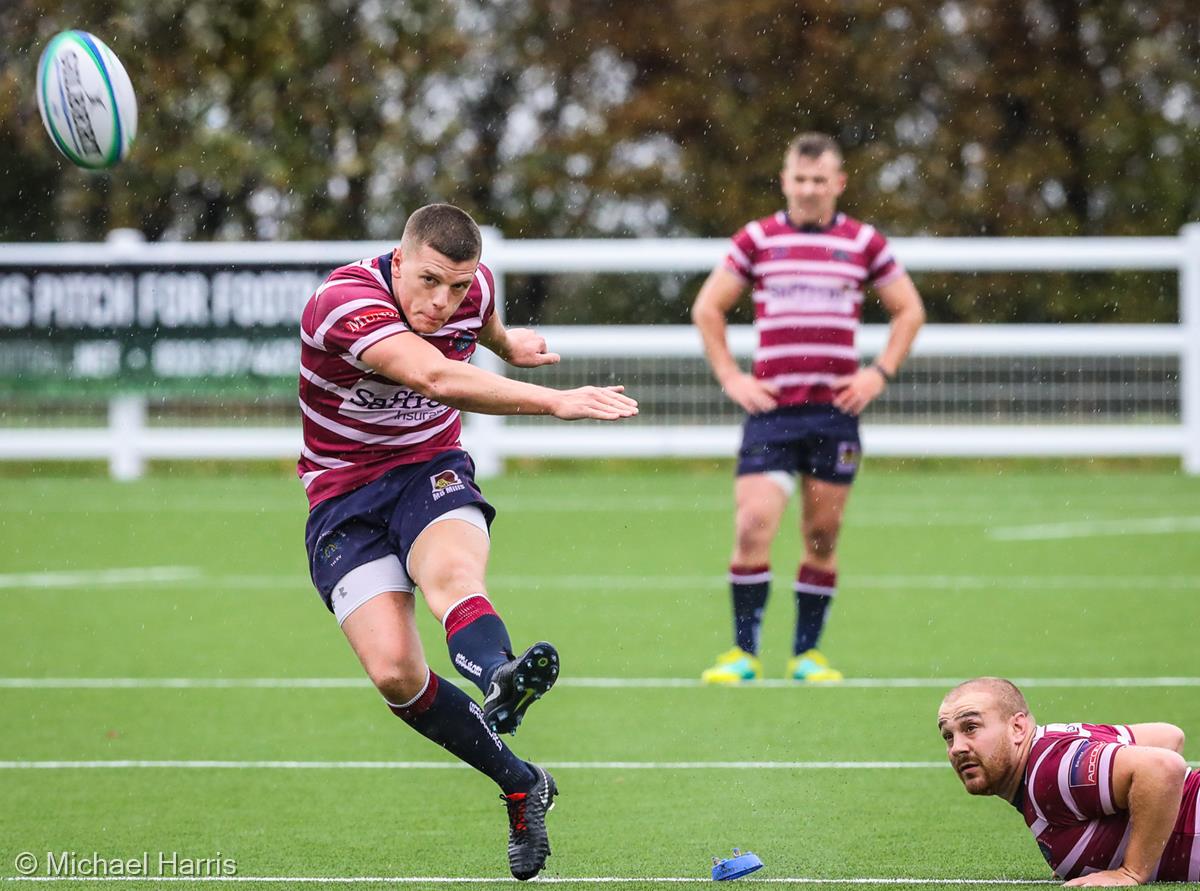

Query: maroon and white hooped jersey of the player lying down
[1014,724,1200,881]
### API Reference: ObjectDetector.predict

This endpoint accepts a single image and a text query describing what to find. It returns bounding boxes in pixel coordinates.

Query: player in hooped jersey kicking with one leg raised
[299,204,637,879]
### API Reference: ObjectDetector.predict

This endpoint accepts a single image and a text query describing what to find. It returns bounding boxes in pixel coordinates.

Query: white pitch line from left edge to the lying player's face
[0,760,949,771]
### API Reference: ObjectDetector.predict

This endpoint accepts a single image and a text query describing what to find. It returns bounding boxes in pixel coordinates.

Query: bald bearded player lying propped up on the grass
[937,677,1200,886]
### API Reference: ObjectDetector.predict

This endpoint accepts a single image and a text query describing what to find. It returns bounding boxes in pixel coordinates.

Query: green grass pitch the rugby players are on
[0,465,1200,889]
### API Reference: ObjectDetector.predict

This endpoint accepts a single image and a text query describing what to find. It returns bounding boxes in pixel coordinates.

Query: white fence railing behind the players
[0,225,1200,479]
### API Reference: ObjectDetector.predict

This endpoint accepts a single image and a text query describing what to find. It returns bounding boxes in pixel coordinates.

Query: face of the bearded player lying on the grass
[937,689,1019,795]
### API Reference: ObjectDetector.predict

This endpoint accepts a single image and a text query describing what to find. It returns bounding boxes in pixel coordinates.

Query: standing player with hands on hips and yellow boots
[692,133,925,683]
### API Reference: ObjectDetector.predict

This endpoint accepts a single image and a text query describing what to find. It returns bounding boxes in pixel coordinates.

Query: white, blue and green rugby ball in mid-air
[37,31,138,171]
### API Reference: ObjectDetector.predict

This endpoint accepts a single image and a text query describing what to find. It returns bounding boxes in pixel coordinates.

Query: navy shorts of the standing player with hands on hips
[738,405,863,485]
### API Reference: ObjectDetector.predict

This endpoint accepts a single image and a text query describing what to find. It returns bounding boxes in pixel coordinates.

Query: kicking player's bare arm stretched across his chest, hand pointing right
[361,333,637,420]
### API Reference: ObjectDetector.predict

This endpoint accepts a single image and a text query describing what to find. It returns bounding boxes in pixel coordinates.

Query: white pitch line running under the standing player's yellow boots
[0,677,1200,690]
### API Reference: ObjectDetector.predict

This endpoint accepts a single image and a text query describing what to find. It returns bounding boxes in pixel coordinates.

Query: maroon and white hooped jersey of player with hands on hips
[725,211,905,406]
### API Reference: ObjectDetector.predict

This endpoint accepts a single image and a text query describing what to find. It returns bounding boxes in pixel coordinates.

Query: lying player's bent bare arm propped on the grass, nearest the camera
[1067,746,1188,887]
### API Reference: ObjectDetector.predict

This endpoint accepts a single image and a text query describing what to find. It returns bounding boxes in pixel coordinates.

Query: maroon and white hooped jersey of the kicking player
[296,252,496,509]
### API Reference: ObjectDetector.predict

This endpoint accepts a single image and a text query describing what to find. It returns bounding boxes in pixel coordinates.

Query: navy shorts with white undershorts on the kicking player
[305,449,496,623]
